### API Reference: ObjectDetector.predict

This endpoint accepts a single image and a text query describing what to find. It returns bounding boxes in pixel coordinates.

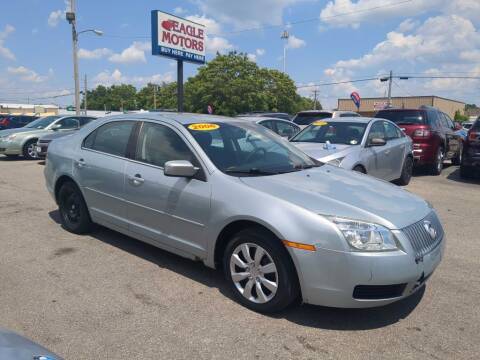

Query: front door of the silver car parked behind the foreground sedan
[365,120,390,179]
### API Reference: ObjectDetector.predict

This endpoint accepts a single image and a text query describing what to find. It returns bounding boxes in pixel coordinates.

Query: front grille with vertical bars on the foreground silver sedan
[402,211,444,259]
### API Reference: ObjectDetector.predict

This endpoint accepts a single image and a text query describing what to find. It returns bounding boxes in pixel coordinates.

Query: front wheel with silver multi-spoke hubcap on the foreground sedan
[223,228,300,313]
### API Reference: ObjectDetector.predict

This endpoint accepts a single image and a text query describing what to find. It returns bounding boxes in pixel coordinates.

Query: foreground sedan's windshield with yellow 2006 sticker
[185,122,322,176]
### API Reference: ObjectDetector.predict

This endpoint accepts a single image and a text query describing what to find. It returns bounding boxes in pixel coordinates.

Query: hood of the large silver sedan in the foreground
[240,164,431,229]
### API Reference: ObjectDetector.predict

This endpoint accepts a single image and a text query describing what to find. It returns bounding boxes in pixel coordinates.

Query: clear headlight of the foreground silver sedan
[328,217,397,251]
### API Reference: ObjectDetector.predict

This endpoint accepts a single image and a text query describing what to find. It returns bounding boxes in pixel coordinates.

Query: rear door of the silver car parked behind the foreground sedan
[383,121,406,180]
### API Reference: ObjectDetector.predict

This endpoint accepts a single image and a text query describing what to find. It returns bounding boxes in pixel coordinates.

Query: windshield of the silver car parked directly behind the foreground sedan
[291,120,367,145]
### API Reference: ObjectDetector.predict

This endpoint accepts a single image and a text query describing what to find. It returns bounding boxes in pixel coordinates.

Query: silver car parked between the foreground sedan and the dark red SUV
[290,117,413,185]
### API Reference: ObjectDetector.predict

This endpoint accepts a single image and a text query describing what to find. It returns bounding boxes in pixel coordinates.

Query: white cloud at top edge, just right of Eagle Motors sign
[198,0,302,29]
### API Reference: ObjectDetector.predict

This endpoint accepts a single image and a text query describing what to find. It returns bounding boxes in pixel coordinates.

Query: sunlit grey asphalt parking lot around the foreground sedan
[0,157,480,359]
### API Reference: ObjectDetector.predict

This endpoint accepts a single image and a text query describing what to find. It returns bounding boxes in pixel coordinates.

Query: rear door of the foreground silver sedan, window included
[73,120,135,229]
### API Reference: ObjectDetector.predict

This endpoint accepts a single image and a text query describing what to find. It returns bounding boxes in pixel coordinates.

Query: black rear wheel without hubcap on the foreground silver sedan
[58,181,93,234]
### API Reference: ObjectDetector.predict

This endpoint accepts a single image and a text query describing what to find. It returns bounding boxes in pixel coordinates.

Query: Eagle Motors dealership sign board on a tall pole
[152,10,206,64]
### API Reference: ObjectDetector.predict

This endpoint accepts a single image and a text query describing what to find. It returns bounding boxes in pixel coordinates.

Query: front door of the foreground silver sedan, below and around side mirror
[125,121,211,258]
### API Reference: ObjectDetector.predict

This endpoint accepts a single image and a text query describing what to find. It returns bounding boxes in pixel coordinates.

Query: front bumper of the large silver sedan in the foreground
[289,232,445,308]
